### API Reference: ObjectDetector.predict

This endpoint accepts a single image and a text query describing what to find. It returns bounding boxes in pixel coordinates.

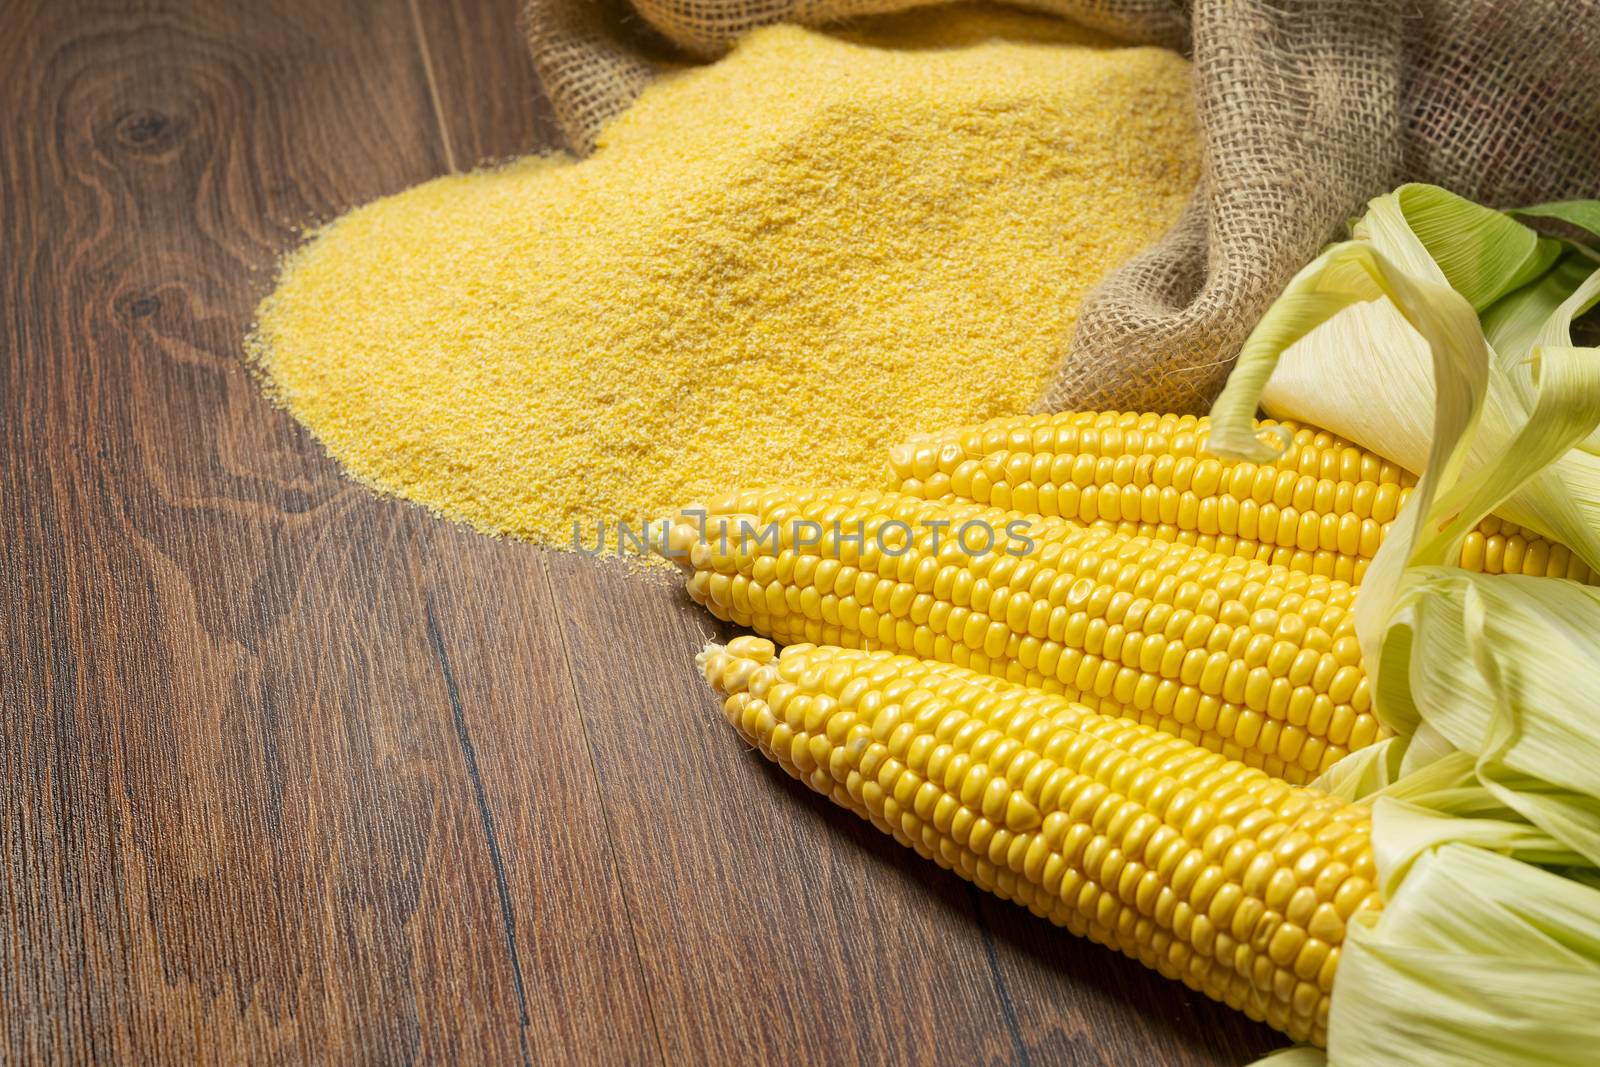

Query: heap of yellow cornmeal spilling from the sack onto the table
[251,8,1198,547]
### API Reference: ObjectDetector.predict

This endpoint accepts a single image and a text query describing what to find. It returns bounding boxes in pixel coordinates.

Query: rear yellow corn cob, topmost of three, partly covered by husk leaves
[888,411,1594,584]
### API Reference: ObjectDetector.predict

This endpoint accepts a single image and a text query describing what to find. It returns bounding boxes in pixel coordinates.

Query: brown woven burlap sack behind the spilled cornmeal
[526,0,1600,411]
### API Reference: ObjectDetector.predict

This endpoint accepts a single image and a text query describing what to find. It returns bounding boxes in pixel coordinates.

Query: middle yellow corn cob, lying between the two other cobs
[669,490,1387,782]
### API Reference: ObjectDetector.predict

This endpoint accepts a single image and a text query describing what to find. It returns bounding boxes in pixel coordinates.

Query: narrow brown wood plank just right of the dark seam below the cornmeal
[427,547,659,1064]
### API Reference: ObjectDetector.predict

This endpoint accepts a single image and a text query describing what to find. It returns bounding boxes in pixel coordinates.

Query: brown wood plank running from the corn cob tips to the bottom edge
[547,553,1021,1064]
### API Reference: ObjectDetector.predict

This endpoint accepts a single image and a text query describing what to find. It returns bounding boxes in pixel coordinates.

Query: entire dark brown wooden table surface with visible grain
[0,0,1282,1065]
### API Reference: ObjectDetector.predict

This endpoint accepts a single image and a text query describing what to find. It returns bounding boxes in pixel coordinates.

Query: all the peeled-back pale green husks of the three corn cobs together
[1211,183,1600,1067]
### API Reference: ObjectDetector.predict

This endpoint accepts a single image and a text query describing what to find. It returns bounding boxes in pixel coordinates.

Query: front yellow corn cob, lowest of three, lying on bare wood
[698,637,1381,1045]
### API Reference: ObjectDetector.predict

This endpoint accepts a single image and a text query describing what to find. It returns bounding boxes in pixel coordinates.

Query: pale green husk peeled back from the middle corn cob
[1355,255,1600,867]
